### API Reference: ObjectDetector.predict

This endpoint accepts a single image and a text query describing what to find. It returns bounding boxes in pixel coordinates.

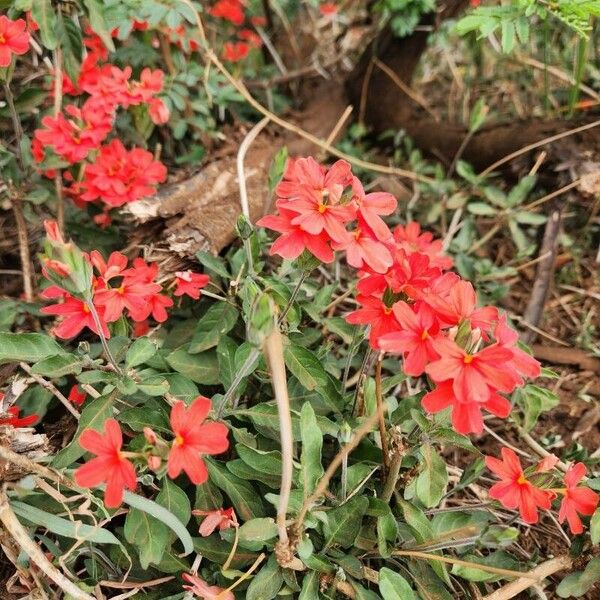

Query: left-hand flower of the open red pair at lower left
[75,419,136,508]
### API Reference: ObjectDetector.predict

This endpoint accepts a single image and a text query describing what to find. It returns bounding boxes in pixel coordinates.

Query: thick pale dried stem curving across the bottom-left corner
[0,491,96,600]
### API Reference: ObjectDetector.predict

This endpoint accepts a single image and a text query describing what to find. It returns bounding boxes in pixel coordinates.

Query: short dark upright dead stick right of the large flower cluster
[522,209,561,344]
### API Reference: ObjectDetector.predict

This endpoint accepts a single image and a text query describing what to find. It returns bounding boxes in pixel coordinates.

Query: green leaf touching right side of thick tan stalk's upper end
[283,342,342,413]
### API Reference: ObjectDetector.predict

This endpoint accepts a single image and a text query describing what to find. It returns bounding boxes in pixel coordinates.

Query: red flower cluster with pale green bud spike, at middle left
[41,222,209,339]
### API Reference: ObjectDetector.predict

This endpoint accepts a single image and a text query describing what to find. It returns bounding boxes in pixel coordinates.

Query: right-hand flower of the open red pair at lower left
[167,396,229,485]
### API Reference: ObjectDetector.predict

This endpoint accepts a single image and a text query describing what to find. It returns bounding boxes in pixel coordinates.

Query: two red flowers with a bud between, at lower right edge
[485,448,600,535]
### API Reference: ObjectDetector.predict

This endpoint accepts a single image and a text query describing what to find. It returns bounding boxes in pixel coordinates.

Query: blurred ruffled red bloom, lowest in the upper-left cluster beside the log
[81,139,167,206]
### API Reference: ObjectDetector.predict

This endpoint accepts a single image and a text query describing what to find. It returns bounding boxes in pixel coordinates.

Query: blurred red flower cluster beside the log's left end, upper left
[32,29,169,207]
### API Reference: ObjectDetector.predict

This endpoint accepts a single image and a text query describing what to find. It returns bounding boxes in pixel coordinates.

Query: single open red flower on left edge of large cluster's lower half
[379,302,440,377]
